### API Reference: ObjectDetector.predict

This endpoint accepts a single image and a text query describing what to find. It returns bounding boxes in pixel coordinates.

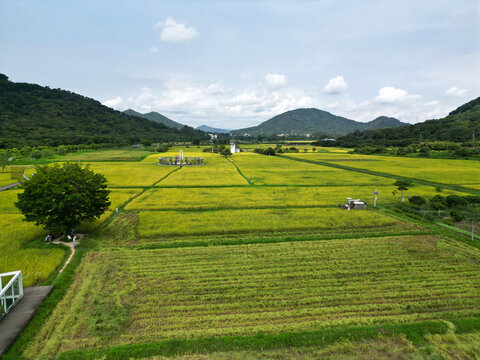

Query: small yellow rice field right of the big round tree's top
[83,162,174,187]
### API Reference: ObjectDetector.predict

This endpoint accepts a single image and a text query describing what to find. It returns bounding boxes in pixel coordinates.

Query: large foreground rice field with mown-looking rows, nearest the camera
[24,236,480,359]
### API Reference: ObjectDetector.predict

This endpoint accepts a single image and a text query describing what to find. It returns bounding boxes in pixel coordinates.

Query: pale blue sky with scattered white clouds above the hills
[0,0,480,129]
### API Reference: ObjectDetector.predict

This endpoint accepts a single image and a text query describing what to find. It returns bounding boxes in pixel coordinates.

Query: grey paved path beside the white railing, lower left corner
[0,286,53,358]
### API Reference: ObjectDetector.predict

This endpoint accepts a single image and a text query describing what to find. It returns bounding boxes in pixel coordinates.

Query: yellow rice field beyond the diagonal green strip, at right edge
[287,153,480,187]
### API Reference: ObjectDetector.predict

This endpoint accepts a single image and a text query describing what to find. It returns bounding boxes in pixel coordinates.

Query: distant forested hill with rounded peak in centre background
[232,108,405,136]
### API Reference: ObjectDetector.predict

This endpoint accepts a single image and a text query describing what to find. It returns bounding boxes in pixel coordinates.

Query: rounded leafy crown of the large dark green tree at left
[15,163,110,232]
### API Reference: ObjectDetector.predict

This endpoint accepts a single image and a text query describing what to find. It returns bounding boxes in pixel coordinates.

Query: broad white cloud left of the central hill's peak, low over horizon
[104,78,320,128]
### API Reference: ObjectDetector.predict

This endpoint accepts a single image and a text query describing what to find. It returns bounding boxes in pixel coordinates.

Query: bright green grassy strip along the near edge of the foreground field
[54,318,480,360]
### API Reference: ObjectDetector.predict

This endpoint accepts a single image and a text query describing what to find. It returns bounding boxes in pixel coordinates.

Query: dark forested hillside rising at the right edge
[338,97,480,146]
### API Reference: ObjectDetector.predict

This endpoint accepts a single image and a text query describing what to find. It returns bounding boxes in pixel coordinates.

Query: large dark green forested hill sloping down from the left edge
[0,74,206,148]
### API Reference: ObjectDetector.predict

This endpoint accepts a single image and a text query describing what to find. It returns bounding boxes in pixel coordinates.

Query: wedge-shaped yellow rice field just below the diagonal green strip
[231,153,392,186]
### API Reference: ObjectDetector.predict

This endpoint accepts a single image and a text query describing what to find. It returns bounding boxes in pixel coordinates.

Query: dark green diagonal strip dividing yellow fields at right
[277,155,480,195]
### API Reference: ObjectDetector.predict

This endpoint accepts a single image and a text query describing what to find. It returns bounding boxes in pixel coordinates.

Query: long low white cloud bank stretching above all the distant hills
[104,77,453,129]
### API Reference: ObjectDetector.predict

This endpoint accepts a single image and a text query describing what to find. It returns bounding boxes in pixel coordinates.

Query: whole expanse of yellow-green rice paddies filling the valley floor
[0,147,480,359]
